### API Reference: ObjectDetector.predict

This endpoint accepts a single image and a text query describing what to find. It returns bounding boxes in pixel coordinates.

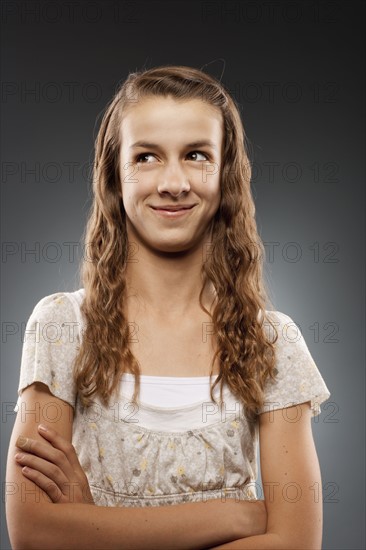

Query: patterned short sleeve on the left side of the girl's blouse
[14,292,80,411]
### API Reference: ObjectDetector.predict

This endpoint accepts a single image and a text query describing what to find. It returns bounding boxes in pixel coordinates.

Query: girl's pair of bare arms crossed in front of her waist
[6,383,322,550]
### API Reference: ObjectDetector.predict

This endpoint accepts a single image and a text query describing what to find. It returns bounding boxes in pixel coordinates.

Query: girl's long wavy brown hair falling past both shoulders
[74,65,278,421]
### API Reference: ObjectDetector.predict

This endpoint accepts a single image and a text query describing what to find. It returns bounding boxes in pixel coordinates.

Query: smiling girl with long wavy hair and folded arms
[6,66,330,549]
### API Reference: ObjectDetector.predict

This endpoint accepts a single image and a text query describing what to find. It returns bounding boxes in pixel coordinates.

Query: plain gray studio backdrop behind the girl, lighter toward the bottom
[1,0,365,549]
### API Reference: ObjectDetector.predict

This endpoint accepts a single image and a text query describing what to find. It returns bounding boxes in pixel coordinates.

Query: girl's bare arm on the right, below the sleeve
[209,402,323,550]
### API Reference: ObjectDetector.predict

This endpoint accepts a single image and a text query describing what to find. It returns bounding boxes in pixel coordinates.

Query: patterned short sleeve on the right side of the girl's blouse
[259,311,331,416]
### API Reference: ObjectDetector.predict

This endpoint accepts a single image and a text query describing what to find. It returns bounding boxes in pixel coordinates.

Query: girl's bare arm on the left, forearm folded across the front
[6,383,254,550]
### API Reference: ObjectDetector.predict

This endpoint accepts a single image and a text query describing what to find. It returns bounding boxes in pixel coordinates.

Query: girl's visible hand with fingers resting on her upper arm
[15,426,94,504]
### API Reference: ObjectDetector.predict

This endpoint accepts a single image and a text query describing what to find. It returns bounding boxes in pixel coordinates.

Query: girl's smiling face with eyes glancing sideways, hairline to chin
[120,97,223,252]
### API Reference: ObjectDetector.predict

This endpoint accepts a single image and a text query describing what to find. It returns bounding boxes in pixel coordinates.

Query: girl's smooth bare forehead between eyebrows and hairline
[121,96,223,146]
